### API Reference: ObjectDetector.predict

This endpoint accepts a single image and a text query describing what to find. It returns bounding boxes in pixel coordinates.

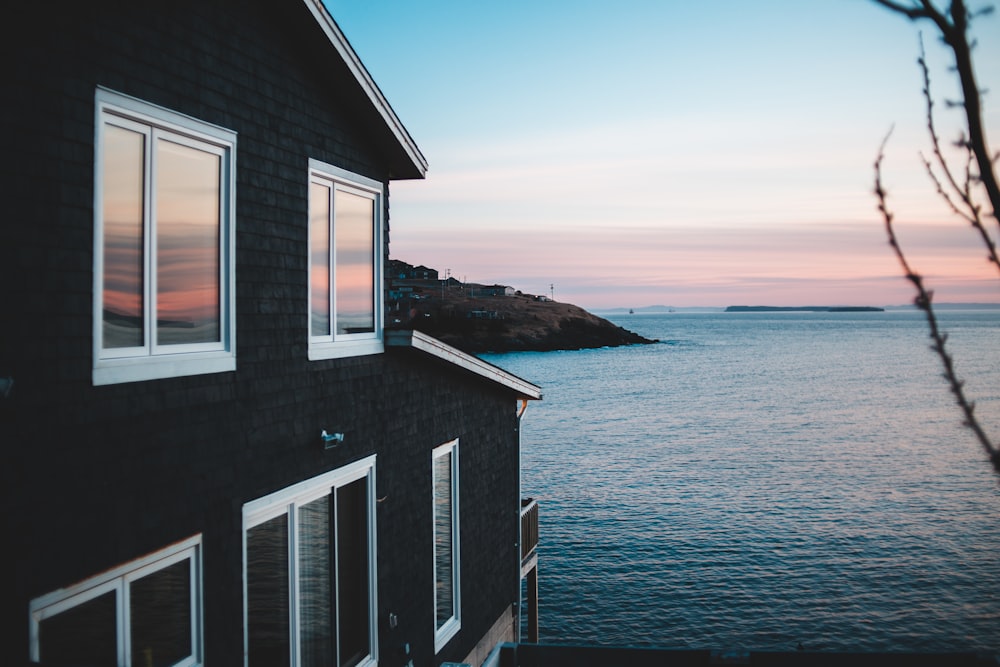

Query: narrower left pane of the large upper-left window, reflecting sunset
[101,125,145,348]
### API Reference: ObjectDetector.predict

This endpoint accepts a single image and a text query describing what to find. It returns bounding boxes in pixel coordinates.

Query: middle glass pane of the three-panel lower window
[299,496,334,667]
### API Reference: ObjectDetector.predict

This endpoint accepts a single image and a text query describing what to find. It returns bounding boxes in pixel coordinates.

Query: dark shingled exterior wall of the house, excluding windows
[0,0,519,665]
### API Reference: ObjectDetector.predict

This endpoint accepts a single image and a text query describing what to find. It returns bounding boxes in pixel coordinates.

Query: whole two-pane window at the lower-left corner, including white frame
[30,536,203,667]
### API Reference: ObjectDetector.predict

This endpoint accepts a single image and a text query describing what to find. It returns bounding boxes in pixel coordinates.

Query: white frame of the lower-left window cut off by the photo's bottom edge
[29,534,205,667]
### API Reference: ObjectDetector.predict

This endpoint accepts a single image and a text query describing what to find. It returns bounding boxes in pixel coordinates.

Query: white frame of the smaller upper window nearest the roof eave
[306,158,385,361]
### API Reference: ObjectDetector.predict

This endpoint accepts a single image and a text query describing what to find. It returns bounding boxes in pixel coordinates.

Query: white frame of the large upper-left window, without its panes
[93,88,236,385]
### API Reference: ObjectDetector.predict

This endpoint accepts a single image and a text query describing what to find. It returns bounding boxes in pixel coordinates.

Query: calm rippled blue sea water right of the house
[485,311,1000,652]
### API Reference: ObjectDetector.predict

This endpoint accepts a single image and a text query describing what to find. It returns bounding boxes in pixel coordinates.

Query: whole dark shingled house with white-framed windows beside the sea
[0,0,541,667]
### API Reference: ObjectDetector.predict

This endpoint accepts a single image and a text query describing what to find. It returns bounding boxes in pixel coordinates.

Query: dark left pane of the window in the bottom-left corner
[38,591,118,667]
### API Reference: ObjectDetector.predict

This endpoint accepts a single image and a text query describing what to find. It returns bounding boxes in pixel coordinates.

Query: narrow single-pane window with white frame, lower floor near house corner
[431,440,462,651]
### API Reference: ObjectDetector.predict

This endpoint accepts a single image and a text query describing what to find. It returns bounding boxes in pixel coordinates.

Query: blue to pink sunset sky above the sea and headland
[325,0,1000,310]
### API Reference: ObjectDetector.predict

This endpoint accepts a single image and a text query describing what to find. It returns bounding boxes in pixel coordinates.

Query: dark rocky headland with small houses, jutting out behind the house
[388,260,658,354]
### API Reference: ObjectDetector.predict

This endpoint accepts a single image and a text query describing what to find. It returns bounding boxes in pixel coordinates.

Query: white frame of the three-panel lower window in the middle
[243,454,378,667]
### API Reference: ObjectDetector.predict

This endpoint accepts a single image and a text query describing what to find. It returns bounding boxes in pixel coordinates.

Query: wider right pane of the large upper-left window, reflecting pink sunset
[155,140,222,345]
